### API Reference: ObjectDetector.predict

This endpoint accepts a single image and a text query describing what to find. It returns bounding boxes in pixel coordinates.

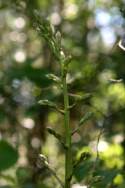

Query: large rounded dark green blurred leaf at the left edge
[0,140,18,171]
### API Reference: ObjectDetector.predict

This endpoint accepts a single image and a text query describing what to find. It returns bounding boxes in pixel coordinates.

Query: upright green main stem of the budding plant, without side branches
[62,70,72,188]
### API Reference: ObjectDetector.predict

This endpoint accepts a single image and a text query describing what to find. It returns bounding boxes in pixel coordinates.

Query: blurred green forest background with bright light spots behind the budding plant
[0,0,125,188]
